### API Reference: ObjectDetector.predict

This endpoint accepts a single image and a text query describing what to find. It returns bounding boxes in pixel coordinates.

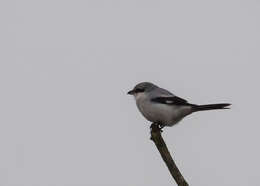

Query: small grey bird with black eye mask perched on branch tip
[128,82,231,128]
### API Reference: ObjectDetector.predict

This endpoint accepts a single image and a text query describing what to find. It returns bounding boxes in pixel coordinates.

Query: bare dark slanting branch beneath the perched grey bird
[151,123,189,186]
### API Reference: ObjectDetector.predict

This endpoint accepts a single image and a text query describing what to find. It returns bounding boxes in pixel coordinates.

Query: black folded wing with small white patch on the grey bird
[151,96,191,105]
